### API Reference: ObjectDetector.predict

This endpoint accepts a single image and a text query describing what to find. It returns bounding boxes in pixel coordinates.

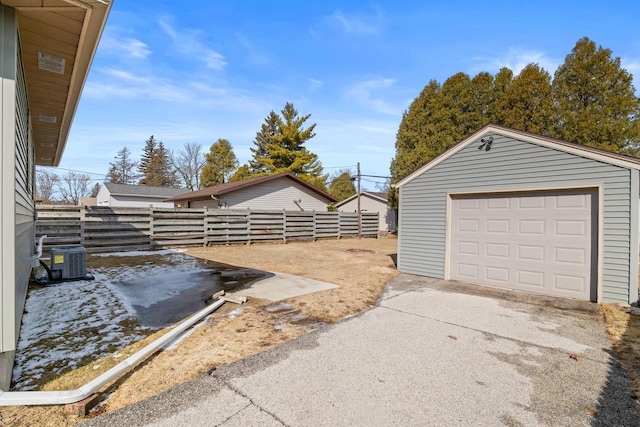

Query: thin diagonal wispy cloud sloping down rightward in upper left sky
[158,19,227,71]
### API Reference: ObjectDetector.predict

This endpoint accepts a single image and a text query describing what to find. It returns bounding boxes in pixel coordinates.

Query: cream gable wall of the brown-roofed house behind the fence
[189,177,329,211]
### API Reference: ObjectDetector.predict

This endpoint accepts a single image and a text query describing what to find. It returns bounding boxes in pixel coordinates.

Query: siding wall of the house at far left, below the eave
[0,6,35,390]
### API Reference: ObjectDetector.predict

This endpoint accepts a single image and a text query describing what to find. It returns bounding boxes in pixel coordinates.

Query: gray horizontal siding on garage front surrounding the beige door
[398,133,638,303]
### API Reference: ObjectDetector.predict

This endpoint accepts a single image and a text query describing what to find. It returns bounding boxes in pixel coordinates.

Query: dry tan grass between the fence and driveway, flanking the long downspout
[0,237,397,426]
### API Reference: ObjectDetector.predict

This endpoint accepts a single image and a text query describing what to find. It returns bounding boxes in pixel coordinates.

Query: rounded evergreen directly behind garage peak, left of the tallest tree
[491,64,554,135]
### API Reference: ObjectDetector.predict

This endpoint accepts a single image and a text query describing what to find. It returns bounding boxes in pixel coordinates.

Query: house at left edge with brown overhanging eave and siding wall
[0,0,111,390]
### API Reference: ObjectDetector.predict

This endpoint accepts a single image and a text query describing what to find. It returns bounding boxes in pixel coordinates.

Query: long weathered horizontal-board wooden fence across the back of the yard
[36,205,378,252]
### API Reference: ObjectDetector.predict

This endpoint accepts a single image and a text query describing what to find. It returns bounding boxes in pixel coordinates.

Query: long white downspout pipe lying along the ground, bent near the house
[0,299,225,406]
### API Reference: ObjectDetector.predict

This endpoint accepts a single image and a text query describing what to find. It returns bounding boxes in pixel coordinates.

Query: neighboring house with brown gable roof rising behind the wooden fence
[168,172,337,211]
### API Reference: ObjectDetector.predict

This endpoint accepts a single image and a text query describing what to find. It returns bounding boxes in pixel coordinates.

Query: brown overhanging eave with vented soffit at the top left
[0,0,111,166]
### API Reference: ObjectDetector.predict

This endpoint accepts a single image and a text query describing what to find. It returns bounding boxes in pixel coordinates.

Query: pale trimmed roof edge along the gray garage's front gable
[394,124,640,188]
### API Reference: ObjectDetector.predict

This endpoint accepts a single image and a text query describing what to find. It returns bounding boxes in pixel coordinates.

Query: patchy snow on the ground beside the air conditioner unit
[13,250,202,390]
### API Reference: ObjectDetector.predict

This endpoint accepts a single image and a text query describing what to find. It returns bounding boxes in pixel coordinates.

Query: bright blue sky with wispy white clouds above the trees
[60,0,640,189]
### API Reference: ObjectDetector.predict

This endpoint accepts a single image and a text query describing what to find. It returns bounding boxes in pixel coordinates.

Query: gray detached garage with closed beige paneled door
[396,125,640,304]
